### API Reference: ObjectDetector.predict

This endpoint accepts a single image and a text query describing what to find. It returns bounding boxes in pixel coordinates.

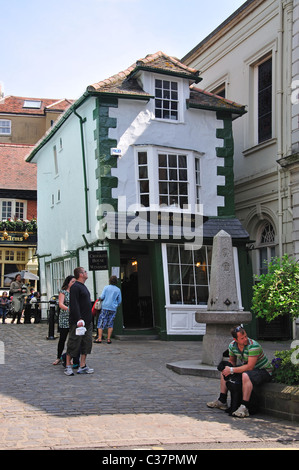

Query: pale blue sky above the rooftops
[0,0,245,99]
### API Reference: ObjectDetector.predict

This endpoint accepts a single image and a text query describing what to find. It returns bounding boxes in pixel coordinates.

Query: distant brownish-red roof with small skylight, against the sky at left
[0,96,74,115]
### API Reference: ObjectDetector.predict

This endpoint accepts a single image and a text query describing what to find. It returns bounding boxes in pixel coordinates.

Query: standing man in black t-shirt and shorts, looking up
[64,268,94,375]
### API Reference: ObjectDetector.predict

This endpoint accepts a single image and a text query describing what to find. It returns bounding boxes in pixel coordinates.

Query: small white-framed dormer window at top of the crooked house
[155,79,179,121]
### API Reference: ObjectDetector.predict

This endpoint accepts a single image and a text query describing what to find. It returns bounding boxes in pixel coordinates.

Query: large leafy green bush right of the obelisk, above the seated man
[252,255,299,322]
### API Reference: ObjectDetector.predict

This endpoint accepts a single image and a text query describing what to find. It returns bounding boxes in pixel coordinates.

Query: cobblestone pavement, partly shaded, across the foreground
[0,323,299,450]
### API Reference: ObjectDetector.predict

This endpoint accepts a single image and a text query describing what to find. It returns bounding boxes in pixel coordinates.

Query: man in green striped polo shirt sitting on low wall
[207,325,272,418]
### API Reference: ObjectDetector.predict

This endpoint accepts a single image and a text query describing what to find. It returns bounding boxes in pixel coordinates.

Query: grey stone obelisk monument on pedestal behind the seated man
[195,230,251,366]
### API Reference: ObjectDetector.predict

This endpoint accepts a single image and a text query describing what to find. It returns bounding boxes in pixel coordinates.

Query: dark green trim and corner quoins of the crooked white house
[27,86,255,340]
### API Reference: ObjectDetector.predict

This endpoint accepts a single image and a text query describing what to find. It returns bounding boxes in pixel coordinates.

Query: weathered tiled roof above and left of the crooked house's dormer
[87,51,201,97]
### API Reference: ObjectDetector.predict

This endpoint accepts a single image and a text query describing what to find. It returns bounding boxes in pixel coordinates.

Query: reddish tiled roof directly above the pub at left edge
[0,143,37,191]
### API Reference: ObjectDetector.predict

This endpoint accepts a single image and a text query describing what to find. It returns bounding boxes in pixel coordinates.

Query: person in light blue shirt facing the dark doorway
[94,276,121,344]
